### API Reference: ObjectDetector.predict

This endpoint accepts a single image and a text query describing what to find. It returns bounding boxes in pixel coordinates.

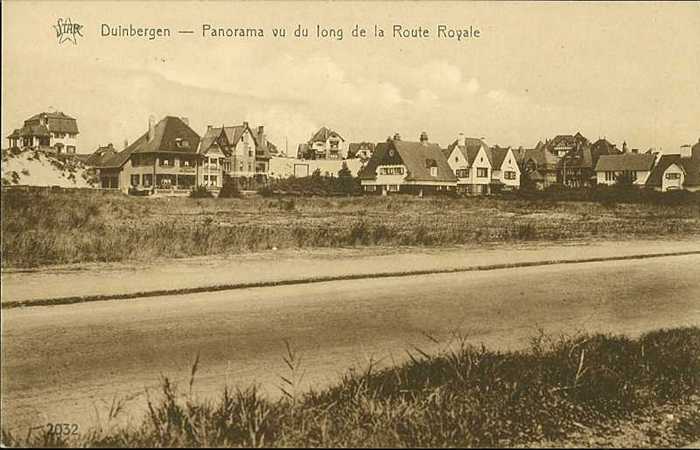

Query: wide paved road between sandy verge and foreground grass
[2,255,700,430]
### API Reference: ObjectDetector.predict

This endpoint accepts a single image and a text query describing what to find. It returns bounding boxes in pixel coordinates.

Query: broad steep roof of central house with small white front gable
[359,140,457,181]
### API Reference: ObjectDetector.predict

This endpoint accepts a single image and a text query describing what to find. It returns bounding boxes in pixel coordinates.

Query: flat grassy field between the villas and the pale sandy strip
[2,191,700,268]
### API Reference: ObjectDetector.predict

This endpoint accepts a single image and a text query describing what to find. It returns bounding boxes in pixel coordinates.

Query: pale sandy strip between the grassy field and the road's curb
[2,239,700,302]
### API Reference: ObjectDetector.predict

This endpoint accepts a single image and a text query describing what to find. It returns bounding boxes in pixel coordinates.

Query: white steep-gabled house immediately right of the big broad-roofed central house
[445,133,494,194]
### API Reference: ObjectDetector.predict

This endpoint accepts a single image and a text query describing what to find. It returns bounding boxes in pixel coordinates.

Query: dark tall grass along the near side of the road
[3,327,700,447]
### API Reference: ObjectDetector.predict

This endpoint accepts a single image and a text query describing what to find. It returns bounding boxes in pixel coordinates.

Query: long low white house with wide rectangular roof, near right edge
[595,153,656,186]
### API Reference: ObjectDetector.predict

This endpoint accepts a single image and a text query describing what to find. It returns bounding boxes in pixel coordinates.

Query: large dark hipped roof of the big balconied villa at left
[99,116,200,167]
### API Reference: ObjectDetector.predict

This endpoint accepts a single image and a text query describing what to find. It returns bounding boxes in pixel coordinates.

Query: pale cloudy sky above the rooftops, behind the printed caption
[2,1,700,153]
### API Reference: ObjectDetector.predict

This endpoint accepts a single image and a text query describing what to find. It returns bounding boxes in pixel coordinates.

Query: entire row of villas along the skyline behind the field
[8,112,700,195]
